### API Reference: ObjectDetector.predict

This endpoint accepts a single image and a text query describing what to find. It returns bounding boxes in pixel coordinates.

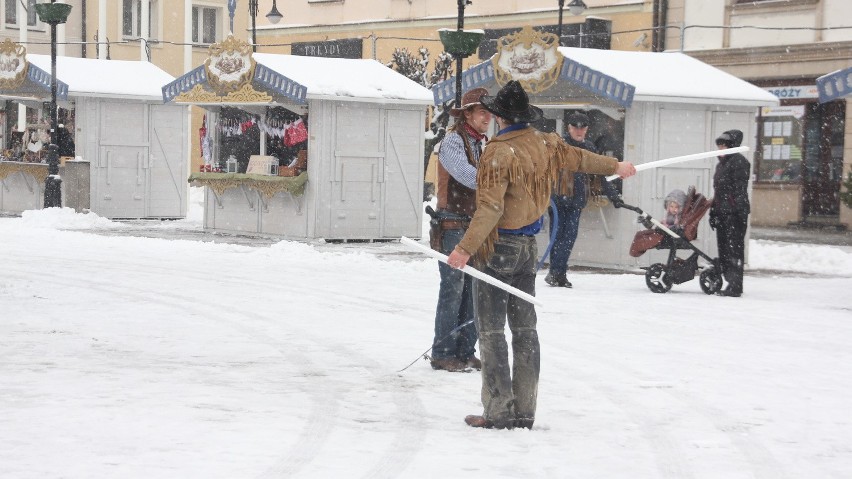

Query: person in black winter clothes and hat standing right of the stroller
[710,130,751,297]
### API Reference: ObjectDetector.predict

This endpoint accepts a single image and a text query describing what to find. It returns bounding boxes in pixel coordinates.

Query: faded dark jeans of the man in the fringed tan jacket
[473,235,541,427]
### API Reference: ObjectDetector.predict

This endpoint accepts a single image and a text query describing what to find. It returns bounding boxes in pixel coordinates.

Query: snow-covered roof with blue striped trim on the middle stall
[162,53,432,105]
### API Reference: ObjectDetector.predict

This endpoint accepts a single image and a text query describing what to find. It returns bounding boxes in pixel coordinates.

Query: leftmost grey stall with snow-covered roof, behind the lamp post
[0,40,189,218]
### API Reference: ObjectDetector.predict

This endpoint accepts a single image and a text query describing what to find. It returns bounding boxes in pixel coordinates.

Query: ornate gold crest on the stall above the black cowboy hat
[492,25,563,93]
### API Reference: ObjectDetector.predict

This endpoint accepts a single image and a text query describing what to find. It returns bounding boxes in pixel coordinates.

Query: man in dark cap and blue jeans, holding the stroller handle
[544,112,621,288]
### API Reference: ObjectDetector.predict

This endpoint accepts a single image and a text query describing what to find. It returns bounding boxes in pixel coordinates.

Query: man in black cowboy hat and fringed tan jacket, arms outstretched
[447,81,636,429]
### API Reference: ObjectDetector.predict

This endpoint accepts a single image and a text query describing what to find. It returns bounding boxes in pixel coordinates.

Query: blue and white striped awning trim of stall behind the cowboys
[432,54,636,108]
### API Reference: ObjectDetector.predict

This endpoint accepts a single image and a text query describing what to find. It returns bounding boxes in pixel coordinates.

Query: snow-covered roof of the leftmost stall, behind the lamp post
[16,54,174,100]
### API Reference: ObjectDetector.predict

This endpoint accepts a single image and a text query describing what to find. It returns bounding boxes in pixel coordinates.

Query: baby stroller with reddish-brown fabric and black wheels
[622,186,722,294]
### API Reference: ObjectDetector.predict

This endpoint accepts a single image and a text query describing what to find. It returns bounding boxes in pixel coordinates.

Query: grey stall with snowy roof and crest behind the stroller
[433,27,778,269]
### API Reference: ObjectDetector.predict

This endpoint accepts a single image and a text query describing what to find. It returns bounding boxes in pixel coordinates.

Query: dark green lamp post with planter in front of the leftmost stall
[35,0,71,208]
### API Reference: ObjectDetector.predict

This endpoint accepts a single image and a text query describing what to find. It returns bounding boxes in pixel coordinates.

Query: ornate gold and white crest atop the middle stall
[204,35,255,95]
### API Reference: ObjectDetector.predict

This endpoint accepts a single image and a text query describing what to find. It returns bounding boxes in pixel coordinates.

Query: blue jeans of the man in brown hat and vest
[432,229,478,359]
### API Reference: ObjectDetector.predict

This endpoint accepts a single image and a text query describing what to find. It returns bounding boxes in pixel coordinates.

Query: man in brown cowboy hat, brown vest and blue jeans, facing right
[430,88,491,372]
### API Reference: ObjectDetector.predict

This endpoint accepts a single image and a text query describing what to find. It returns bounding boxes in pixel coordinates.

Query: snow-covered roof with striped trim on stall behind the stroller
[433,47,778,108]
